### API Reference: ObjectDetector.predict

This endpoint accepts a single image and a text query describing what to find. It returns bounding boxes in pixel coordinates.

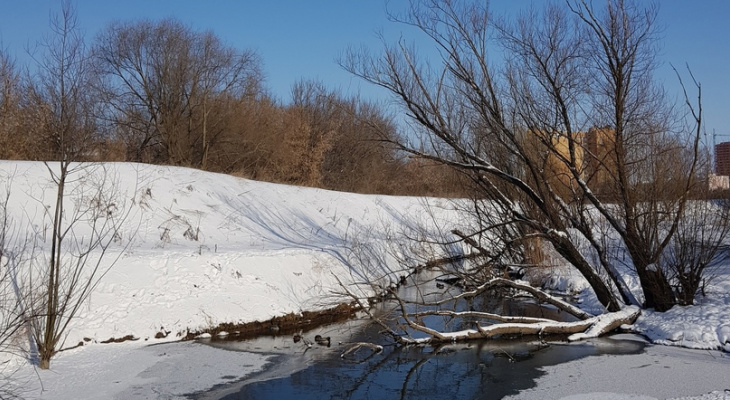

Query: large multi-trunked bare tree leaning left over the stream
[342,0,702,344]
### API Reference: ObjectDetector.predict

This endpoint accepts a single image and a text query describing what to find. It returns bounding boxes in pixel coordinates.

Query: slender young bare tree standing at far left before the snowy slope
[21,2,135,369]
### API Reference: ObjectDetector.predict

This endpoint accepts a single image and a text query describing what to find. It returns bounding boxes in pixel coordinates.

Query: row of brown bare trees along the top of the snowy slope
[0,10,462,195]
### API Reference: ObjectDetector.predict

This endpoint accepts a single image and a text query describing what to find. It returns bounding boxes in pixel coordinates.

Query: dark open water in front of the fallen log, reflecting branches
[195,321,645,400]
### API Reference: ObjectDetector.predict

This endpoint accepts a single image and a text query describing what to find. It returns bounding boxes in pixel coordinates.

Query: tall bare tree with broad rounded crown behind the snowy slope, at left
[93,19,262,167]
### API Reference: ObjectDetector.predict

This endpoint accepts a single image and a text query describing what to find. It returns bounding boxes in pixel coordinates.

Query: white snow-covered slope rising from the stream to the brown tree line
[0,161,460,346]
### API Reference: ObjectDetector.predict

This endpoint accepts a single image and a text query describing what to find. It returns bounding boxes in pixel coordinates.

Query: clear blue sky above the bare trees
[0,0,730,141]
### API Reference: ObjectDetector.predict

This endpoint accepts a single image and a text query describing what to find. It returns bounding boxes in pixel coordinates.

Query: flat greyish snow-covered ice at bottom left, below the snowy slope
[14,342,269,400]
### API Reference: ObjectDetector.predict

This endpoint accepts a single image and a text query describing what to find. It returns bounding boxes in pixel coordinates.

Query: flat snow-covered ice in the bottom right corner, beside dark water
[508,336,730,400]
